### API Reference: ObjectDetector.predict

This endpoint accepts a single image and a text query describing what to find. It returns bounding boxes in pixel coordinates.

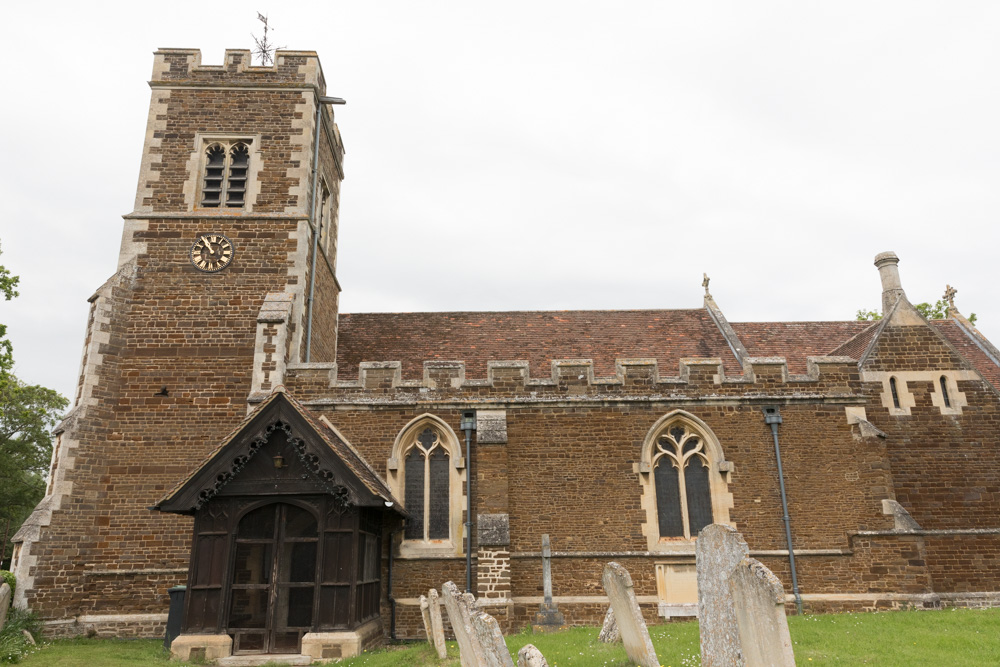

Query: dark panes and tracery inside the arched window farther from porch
[652,424,712,539]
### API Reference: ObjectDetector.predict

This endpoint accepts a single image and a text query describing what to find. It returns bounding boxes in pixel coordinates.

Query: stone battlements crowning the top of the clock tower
[150,49,326,95]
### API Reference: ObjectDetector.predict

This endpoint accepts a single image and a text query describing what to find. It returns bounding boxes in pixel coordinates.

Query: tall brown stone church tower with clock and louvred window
[9,49,344,635]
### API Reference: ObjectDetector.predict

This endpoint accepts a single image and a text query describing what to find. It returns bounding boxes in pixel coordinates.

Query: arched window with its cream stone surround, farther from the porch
[638,410,733,553]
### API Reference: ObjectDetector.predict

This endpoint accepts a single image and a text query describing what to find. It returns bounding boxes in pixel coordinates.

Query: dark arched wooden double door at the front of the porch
[226,503,319,653]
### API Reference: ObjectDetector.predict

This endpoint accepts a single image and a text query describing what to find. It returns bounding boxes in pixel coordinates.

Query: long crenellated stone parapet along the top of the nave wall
[270,357,863,402]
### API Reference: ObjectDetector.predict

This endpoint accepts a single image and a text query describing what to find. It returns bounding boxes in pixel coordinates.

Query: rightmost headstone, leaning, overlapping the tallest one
[729,558,795,667]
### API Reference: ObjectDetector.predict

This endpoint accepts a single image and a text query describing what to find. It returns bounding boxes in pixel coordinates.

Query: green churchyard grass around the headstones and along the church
[11,609,1000,667]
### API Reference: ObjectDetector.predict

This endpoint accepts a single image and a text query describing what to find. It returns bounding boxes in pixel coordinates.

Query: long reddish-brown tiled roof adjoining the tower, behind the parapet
[337,309,744,380]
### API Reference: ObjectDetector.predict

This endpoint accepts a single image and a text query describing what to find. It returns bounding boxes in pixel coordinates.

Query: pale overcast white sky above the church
[0,0,1000,402]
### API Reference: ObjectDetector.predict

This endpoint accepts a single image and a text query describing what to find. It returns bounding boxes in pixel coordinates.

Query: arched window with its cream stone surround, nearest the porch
[386,413,466,558]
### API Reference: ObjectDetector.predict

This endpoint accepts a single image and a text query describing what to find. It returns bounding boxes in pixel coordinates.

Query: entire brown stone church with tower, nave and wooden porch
[13,49,1000,657]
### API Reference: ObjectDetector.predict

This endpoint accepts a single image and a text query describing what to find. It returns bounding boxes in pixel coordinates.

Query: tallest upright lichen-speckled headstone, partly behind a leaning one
[695,523,750,667]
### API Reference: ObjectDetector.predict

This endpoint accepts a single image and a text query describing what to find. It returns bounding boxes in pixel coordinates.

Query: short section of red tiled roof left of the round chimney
[732,320,872,373]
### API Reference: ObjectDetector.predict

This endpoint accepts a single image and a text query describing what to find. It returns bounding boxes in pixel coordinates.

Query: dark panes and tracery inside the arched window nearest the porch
[403,427,451,542]
